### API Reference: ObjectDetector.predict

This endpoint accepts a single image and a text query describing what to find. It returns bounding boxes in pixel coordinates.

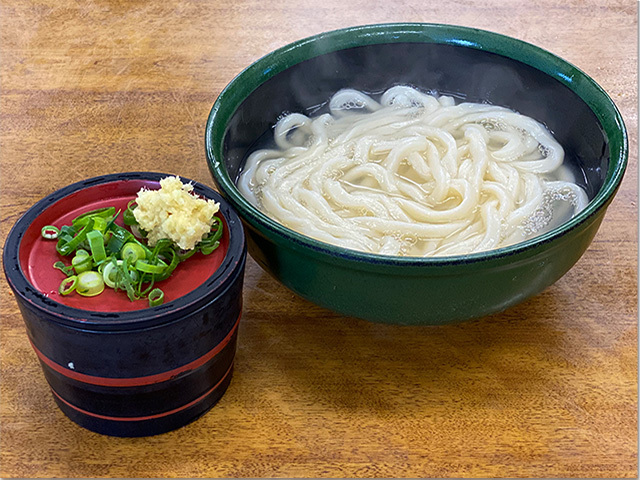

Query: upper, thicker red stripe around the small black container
[29,314,242,387]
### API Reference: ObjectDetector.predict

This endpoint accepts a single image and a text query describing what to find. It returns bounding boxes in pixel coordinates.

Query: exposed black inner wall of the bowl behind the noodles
[223,43,609,198]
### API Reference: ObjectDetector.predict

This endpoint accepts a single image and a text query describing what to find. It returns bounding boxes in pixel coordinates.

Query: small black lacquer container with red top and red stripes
[3,172,246,436]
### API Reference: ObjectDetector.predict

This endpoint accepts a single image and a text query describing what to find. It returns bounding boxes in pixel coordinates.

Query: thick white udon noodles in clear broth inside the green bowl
[238,86,588,257]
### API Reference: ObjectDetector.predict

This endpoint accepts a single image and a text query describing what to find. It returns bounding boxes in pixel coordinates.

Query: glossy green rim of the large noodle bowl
[205,23,628,267]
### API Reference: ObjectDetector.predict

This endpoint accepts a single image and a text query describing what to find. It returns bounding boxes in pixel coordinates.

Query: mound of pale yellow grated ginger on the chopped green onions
[133,177,220,250]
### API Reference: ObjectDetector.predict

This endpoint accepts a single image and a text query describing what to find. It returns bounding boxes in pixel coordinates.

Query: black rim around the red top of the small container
[3,172,246,331]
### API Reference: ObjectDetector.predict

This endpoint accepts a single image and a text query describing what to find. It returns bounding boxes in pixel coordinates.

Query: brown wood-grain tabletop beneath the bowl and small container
[0,0,638,477]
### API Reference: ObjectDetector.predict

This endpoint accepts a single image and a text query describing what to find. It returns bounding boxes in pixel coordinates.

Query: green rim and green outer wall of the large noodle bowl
[205,24,628,325]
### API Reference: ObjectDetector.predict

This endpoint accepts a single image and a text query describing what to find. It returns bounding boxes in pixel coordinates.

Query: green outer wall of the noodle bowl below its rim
[240,215,602,325]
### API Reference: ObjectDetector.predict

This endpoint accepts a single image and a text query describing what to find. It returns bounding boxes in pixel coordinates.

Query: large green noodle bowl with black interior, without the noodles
[205,24,628,325]
